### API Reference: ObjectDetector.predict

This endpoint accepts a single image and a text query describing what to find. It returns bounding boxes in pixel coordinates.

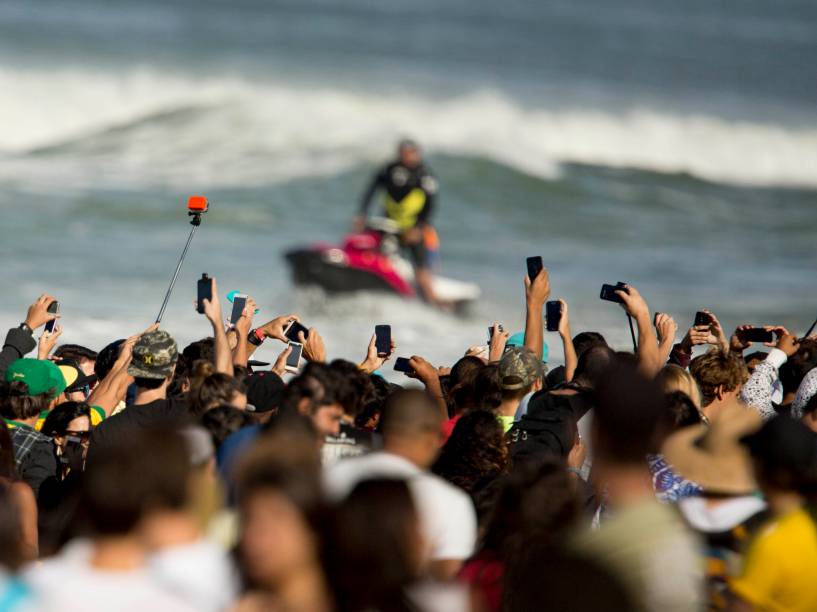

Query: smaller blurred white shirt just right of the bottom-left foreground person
[148,539,238,612]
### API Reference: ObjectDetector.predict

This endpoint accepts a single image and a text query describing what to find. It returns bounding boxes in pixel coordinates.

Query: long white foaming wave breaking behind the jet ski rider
[0,68,817,188]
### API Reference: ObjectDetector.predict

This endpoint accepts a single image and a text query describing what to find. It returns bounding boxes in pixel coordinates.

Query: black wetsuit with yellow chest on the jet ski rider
[360,161,437,268]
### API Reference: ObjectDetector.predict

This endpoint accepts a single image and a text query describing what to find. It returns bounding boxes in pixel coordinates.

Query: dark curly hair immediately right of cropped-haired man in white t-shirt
[431,410,508,495]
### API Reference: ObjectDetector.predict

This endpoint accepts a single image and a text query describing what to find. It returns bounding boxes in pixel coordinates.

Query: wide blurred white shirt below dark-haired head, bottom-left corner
[23,540,195,612]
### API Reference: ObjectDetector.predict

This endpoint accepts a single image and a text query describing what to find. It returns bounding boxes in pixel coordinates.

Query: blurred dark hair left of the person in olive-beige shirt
[482,458,580,560]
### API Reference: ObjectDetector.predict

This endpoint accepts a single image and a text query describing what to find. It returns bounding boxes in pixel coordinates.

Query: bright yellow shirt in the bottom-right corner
[730,508,817,612]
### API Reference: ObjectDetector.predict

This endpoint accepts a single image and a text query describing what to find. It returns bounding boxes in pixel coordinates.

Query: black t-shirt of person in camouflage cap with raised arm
[88,399,192,460]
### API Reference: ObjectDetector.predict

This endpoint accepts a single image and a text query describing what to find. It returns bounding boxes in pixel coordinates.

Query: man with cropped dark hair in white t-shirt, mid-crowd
[324,391,477,580]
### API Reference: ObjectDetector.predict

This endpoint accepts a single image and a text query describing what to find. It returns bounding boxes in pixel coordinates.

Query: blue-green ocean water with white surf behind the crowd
[0,0,817,368]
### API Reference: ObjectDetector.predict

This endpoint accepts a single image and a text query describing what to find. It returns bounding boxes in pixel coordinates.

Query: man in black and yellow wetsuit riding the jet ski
[354,140,437,304]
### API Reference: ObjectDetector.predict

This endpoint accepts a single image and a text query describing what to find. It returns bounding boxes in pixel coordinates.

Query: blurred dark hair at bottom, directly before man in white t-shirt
[324,479,419,612]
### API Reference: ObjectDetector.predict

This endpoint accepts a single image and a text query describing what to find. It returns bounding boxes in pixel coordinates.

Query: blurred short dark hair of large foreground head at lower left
[80,429,191,536]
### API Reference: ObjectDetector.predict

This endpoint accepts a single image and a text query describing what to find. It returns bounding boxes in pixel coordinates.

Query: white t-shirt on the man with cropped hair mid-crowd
[324,451,477,560]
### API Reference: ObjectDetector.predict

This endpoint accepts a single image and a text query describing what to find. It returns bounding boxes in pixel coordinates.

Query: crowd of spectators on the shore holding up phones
[0,270,817,612]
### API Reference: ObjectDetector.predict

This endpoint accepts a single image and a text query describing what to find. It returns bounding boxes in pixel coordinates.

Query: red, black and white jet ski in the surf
[284,219,481,312]
